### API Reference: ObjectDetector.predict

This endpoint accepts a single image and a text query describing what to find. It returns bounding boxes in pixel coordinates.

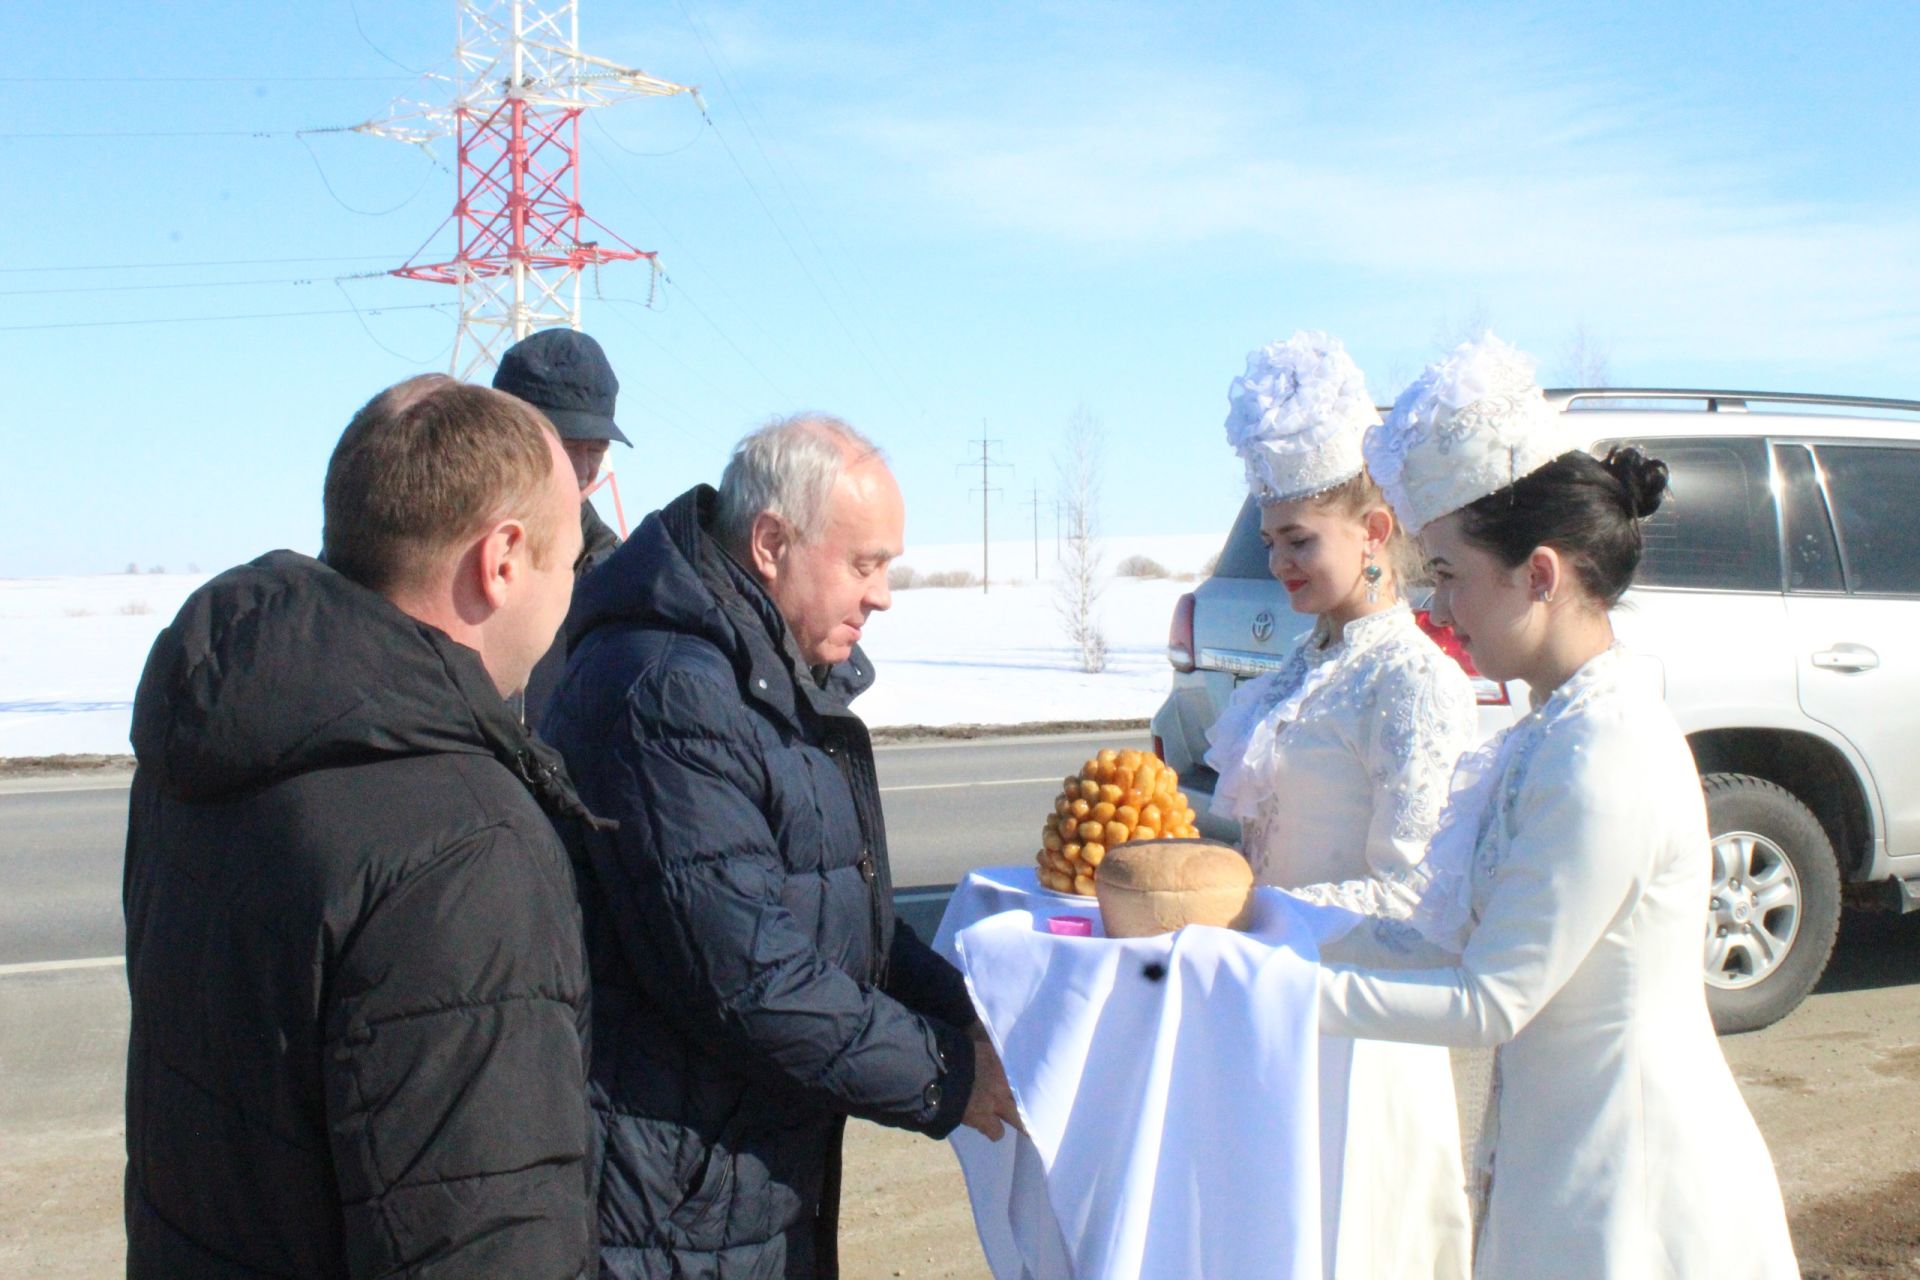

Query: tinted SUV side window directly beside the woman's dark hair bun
[1597,438,1780,591]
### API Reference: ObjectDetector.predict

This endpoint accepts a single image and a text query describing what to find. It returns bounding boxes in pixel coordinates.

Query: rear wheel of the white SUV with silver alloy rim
[1701,773,1839,1034]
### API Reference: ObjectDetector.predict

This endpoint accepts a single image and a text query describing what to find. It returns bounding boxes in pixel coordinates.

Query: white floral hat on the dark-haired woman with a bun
[1365,334,1582,533]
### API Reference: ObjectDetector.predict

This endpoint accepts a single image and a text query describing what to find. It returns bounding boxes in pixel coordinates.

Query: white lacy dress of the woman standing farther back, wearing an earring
[1206,604,1476,1280]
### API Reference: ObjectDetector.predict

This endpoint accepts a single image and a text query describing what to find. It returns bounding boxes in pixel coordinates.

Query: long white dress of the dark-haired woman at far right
[1321,649,1799,1280]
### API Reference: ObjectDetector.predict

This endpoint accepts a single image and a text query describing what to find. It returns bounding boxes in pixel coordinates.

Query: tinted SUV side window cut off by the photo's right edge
[1816,445,1920,595]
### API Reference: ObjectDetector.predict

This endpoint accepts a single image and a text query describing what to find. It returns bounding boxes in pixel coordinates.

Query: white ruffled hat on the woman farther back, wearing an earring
[1227,330,1380,503]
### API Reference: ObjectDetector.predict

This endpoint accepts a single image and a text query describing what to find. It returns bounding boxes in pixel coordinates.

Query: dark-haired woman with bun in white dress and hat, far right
[1321,338,1799,1280]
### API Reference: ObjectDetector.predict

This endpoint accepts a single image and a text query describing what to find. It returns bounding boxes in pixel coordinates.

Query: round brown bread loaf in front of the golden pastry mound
[1094,841,1254,938]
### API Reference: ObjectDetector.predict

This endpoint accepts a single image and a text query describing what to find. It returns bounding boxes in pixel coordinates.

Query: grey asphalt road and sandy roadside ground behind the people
[0,739,1920,1280]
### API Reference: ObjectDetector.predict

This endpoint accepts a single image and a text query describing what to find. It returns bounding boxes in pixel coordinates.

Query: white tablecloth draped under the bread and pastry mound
[935,867,1352,1280]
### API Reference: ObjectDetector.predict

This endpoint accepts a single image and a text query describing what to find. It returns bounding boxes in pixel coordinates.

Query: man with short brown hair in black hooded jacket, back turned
[125,376,595,1280]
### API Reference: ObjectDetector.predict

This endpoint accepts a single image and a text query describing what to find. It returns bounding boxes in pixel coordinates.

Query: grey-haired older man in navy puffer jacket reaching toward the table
[543,416,1018,1280]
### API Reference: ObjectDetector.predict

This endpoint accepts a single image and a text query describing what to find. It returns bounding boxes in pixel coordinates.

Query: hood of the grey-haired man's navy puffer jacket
[566,484,874,720]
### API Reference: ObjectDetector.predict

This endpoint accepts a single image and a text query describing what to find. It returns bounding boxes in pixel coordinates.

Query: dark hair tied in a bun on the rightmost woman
[1461,445,1667,608]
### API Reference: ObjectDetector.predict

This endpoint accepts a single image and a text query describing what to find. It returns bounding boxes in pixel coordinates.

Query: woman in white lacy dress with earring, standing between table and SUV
[1208,334,1476,1280]
